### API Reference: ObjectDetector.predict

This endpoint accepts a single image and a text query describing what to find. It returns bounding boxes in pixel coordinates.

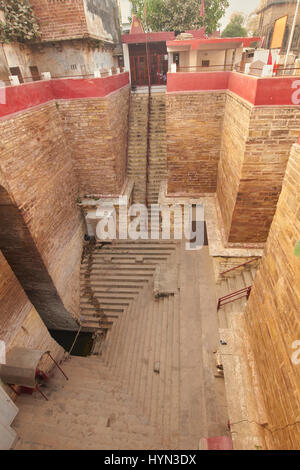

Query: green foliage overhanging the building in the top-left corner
[0,0,40,42]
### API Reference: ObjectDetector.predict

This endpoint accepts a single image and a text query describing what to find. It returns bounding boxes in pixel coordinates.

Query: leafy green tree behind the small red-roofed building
[130,0,229,34]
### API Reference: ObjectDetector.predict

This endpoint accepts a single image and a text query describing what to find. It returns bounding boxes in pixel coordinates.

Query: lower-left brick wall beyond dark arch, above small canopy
[0,252,63,369]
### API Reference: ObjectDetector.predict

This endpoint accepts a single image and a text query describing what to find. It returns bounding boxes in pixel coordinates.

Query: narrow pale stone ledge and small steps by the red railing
[217,262,268,450]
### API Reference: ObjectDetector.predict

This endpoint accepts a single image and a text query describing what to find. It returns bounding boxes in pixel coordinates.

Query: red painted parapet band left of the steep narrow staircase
[0,72,129,117]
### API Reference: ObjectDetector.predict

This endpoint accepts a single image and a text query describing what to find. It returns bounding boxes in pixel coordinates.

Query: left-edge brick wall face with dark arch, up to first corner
[0,102,83,329]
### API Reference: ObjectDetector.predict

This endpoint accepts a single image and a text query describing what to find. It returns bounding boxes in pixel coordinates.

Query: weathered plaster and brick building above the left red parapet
[0,0,123,82]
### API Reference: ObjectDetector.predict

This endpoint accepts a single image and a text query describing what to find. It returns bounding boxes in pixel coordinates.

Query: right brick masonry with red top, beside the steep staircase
[166,73,300,245]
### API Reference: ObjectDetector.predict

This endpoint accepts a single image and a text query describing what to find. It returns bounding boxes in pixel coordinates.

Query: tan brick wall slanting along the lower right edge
[246,144,300,450]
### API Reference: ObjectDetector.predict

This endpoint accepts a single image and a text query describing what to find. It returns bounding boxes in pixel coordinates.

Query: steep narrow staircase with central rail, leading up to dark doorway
[128,93,167,204]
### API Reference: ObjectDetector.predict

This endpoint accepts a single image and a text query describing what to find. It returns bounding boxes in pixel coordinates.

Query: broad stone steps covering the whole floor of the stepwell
[13,240,227,450]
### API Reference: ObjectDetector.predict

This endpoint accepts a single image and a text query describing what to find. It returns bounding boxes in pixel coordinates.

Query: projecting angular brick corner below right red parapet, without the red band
[217,93,300,243]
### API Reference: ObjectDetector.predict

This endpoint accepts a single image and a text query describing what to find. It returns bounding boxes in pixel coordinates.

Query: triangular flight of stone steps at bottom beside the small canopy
[13,357,169,450]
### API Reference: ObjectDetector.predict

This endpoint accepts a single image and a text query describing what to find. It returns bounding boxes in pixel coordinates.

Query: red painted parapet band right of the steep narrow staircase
[167,72,300,106]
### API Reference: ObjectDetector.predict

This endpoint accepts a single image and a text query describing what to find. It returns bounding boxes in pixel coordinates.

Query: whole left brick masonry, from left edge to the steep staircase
[0,76,129,338]
